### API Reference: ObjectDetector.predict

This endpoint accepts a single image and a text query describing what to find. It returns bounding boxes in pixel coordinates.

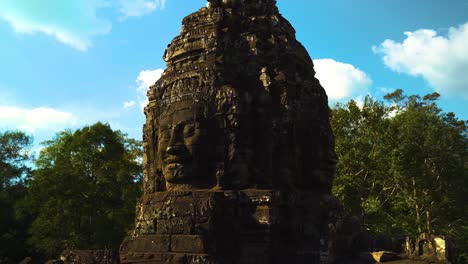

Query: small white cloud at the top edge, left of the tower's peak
[119,0,166,17]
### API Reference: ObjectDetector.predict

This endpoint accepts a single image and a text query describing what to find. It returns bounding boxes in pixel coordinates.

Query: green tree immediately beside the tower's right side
[331,96,397,234]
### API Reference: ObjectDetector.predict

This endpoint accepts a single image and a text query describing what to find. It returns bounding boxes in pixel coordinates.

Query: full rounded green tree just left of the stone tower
[24,123,142,257]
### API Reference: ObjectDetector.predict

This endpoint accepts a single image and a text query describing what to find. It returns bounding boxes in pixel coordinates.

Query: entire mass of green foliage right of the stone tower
[331,90,468,256]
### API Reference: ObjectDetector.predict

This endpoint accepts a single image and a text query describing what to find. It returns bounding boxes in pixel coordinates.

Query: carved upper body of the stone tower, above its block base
[144,0,336,195]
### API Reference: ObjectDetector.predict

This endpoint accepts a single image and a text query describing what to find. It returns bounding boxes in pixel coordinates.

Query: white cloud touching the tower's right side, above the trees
[314,59,372,100]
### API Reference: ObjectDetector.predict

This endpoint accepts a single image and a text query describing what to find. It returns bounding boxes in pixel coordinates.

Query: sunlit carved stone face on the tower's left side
[158,102,215,185]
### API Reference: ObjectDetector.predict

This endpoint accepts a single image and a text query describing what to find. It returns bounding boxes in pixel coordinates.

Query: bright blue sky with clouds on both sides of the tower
[0,0,468,151]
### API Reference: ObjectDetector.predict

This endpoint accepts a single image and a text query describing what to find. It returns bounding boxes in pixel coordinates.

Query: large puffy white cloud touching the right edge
[372,23,468,98]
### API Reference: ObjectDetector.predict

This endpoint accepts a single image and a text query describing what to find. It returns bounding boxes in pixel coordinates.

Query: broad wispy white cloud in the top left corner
[0,0,111,51]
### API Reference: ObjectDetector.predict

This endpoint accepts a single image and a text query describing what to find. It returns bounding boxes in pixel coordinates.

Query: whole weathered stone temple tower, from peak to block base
[120,0,354,264]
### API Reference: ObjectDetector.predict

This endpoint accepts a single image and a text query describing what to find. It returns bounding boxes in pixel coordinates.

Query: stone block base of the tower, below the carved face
[120,190,323,264]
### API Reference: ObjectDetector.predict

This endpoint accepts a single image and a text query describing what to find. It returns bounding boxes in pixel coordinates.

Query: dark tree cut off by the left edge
[0,131,32,262]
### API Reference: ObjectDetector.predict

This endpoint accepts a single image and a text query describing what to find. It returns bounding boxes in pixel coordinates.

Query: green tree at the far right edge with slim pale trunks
[386,90,468,247]
